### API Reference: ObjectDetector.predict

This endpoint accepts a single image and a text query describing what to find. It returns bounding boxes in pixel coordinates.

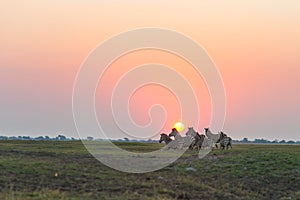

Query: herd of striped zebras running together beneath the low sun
[159,127,232,150]
